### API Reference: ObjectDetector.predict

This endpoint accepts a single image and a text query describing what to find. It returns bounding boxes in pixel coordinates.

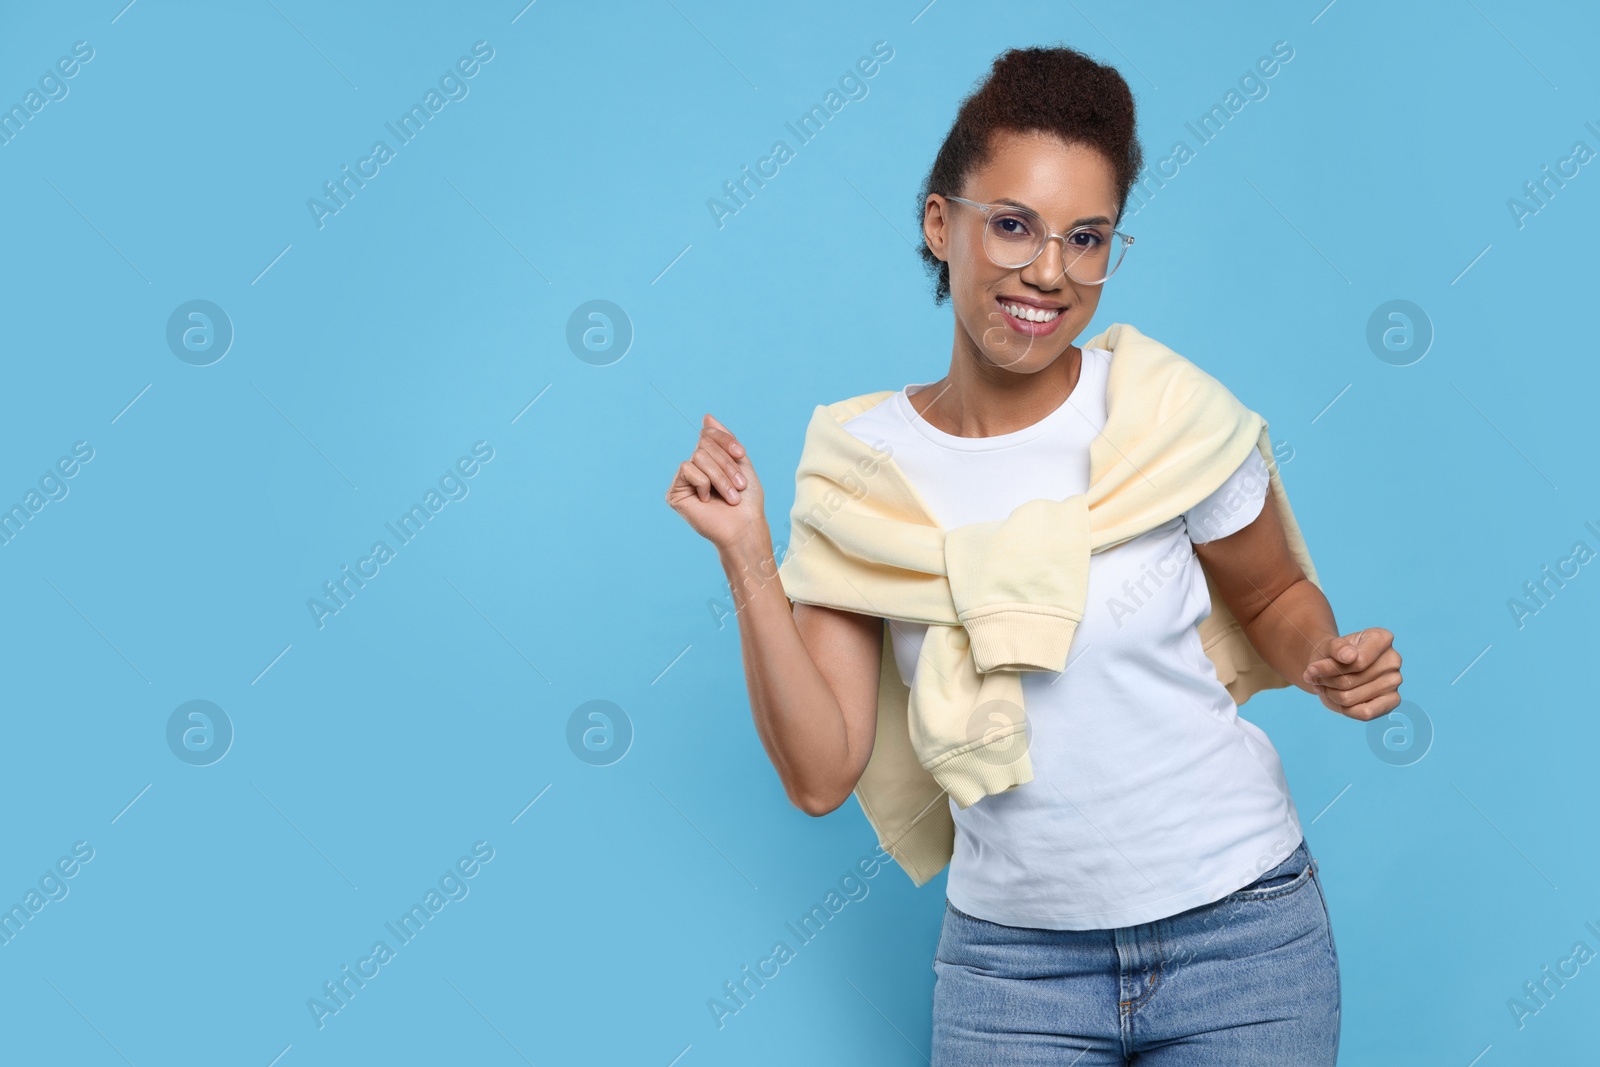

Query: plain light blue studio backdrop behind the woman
[0,0,1600,1067]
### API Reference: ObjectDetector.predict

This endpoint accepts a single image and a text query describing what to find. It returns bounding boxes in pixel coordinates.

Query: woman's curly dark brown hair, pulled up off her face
[917,48,1144,304]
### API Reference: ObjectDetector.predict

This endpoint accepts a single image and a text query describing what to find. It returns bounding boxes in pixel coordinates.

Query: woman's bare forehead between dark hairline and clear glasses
[963,130,1117,221]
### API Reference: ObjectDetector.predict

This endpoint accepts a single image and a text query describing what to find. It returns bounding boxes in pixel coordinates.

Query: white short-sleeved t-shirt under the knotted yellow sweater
[845,349,1302,929]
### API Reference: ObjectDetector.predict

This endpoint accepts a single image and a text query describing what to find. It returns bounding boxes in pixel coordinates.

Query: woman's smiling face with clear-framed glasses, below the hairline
[922,130,1117,374]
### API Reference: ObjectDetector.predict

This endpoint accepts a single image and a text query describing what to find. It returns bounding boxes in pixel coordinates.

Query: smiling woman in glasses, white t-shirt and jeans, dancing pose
[667,48,1400,1067]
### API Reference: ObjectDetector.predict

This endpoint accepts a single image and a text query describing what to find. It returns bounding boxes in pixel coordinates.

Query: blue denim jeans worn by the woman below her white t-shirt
[933,840,1339,1067]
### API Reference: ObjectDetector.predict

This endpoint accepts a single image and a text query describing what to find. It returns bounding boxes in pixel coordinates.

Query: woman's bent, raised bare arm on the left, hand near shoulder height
[667,414,883,816]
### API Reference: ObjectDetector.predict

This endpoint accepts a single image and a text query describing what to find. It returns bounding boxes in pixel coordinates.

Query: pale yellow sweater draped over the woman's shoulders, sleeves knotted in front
[778,323,1320,886]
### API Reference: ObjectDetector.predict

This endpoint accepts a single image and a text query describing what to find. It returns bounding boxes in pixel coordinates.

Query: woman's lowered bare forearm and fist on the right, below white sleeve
[1195,490,1400,721]
